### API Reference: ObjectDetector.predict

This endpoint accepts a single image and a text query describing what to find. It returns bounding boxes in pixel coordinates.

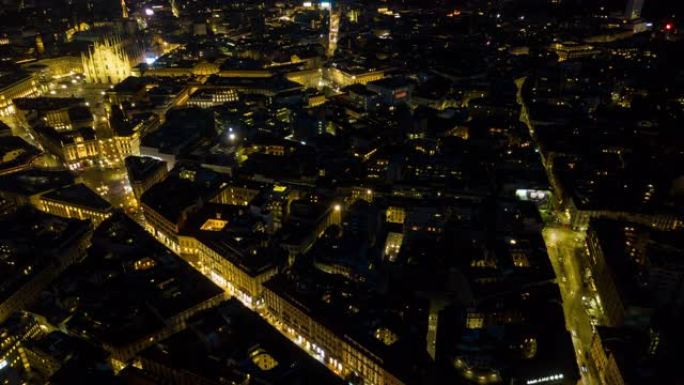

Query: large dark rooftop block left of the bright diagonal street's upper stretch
[32,213,223,348]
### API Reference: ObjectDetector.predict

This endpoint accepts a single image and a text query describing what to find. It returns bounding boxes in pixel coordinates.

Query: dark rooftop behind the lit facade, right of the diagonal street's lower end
[264,268,429,383]
